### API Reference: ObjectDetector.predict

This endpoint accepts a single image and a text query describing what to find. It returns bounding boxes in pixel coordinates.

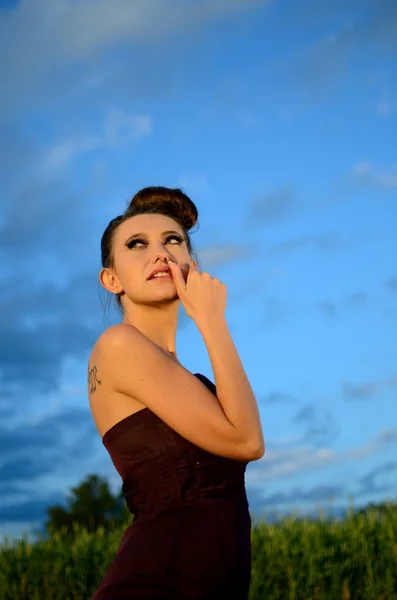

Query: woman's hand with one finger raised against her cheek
[168,260,227,324]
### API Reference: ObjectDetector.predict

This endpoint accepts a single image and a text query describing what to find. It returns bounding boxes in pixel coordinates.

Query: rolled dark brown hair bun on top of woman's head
[124,186,198,231]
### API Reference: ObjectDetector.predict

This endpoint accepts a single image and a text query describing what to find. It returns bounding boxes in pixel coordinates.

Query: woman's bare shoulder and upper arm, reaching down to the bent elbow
[89,323,257,461]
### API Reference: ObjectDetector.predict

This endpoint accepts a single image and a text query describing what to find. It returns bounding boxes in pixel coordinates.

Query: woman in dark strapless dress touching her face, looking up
[88,187,264,600]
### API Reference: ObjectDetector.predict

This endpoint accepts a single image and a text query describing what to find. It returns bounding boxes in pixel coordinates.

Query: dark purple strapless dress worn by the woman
[92,373,251,600]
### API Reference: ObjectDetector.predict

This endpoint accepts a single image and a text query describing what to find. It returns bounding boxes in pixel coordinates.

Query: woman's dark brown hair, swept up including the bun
[101,186,198,309]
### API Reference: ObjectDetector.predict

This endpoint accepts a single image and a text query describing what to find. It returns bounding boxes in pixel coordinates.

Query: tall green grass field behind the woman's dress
[0,506,397,600]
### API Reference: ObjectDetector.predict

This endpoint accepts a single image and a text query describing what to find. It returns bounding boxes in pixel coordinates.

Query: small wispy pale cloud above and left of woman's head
[43,108,152,169]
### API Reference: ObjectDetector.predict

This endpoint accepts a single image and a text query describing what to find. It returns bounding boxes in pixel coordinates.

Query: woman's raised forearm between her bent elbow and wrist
[196,318,265,453]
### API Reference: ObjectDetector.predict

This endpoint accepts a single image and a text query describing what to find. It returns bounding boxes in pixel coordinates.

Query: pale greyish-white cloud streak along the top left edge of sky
[0,0,269,68]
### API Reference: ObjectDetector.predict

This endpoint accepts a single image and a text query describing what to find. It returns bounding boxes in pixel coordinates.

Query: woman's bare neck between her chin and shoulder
[123,300,179,360]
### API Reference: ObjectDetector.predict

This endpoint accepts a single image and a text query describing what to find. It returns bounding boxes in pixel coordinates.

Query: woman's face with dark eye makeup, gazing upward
[108,214,194,304]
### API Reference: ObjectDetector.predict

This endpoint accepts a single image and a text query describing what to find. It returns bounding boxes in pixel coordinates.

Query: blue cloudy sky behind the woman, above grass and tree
[0,0,397,536]
